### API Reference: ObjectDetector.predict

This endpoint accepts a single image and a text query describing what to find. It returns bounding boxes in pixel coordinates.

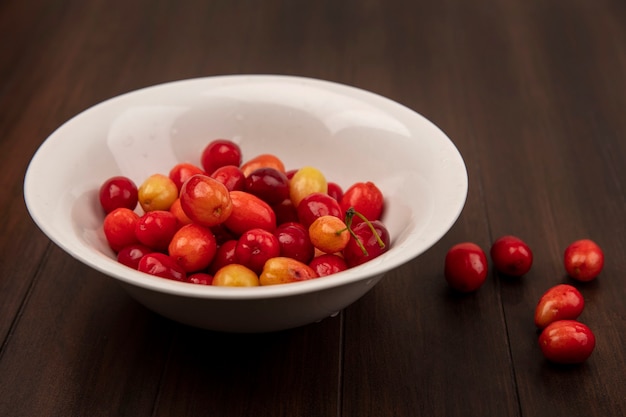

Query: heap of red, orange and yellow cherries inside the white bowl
[99,139,390,286]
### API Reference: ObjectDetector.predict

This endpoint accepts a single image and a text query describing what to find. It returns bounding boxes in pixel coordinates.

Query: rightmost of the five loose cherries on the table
[563,239,604,282]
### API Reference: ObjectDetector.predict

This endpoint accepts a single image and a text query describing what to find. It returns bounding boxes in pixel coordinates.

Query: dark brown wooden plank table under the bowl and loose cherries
[0,0,626,417]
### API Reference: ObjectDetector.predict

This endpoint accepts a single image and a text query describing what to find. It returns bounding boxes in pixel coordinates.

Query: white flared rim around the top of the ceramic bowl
[23,74,468,299]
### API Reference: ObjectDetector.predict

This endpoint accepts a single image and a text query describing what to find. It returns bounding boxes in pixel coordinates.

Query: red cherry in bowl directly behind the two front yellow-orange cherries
[235,229,280,274]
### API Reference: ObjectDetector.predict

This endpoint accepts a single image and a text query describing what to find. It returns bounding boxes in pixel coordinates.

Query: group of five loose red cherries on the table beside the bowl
[444,235,604,364]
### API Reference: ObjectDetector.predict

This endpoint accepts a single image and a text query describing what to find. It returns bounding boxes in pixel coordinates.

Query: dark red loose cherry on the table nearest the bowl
[444,242,488,292]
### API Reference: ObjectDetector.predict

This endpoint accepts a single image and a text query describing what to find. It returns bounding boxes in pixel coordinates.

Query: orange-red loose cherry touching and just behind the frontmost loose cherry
[535,284,585,329]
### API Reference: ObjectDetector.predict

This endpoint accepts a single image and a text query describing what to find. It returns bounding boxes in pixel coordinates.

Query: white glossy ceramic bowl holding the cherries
[24,75,467,332]
